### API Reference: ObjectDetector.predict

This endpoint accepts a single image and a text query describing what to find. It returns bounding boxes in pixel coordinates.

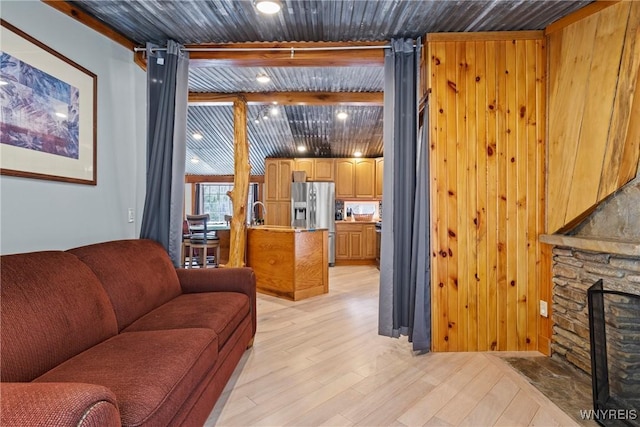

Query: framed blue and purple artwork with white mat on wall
[0,20,97,185]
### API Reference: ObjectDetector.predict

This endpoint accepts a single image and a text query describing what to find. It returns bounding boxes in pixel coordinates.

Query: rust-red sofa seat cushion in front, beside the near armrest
[36,329,218,426]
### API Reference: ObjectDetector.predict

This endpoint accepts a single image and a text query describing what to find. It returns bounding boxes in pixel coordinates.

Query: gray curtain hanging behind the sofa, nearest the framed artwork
[140,41,189,266]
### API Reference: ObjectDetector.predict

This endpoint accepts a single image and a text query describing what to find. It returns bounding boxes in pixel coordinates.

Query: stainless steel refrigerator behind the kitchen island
[291,182,336,266]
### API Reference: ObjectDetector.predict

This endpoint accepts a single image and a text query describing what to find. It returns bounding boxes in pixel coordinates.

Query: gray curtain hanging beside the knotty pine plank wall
[378,39,431,351]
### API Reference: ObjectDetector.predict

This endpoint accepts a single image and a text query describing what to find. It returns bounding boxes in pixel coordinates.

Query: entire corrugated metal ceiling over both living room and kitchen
[68,0,591,175]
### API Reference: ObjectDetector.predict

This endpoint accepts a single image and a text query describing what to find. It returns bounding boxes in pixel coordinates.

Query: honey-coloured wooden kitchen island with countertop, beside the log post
[247,225,329,301]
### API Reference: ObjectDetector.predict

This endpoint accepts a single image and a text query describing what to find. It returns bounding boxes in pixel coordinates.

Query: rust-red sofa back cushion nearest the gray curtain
[68,239,181,331]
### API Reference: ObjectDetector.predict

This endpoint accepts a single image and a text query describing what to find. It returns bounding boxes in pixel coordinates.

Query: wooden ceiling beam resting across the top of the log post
[189,92,384,105]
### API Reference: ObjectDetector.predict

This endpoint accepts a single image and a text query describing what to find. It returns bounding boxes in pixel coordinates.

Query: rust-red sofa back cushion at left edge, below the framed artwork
[0,251,118,382]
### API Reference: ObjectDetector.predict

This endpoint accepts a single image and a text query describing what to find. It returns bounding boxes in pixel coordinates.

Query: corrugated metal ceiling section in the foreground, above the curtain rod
[69,0,591,45]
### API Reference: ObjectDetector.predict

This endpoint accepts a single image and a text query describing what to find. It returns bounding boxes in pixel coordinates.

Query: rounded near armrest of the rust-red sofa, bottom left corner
[0,382,122,427]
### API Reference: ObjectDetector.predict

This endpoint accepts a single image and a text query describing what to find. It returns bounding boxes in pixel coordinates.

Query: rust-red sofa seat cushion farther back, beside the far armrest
[125,292,251,348]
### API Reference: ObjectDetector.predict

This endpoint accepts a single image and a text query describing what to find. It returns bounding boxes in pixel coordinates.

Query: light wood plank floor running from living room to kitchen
[206,266,576,426]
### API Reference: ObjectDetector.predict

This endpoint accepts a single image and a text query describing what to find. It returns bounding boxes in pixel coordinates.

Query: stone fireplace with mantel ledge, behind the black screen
[541,175,640,426]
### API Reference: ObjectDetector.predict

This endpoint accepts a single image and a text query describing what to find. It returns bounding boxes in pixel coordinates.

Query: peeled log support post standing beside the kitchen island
[227,97,251,267]
